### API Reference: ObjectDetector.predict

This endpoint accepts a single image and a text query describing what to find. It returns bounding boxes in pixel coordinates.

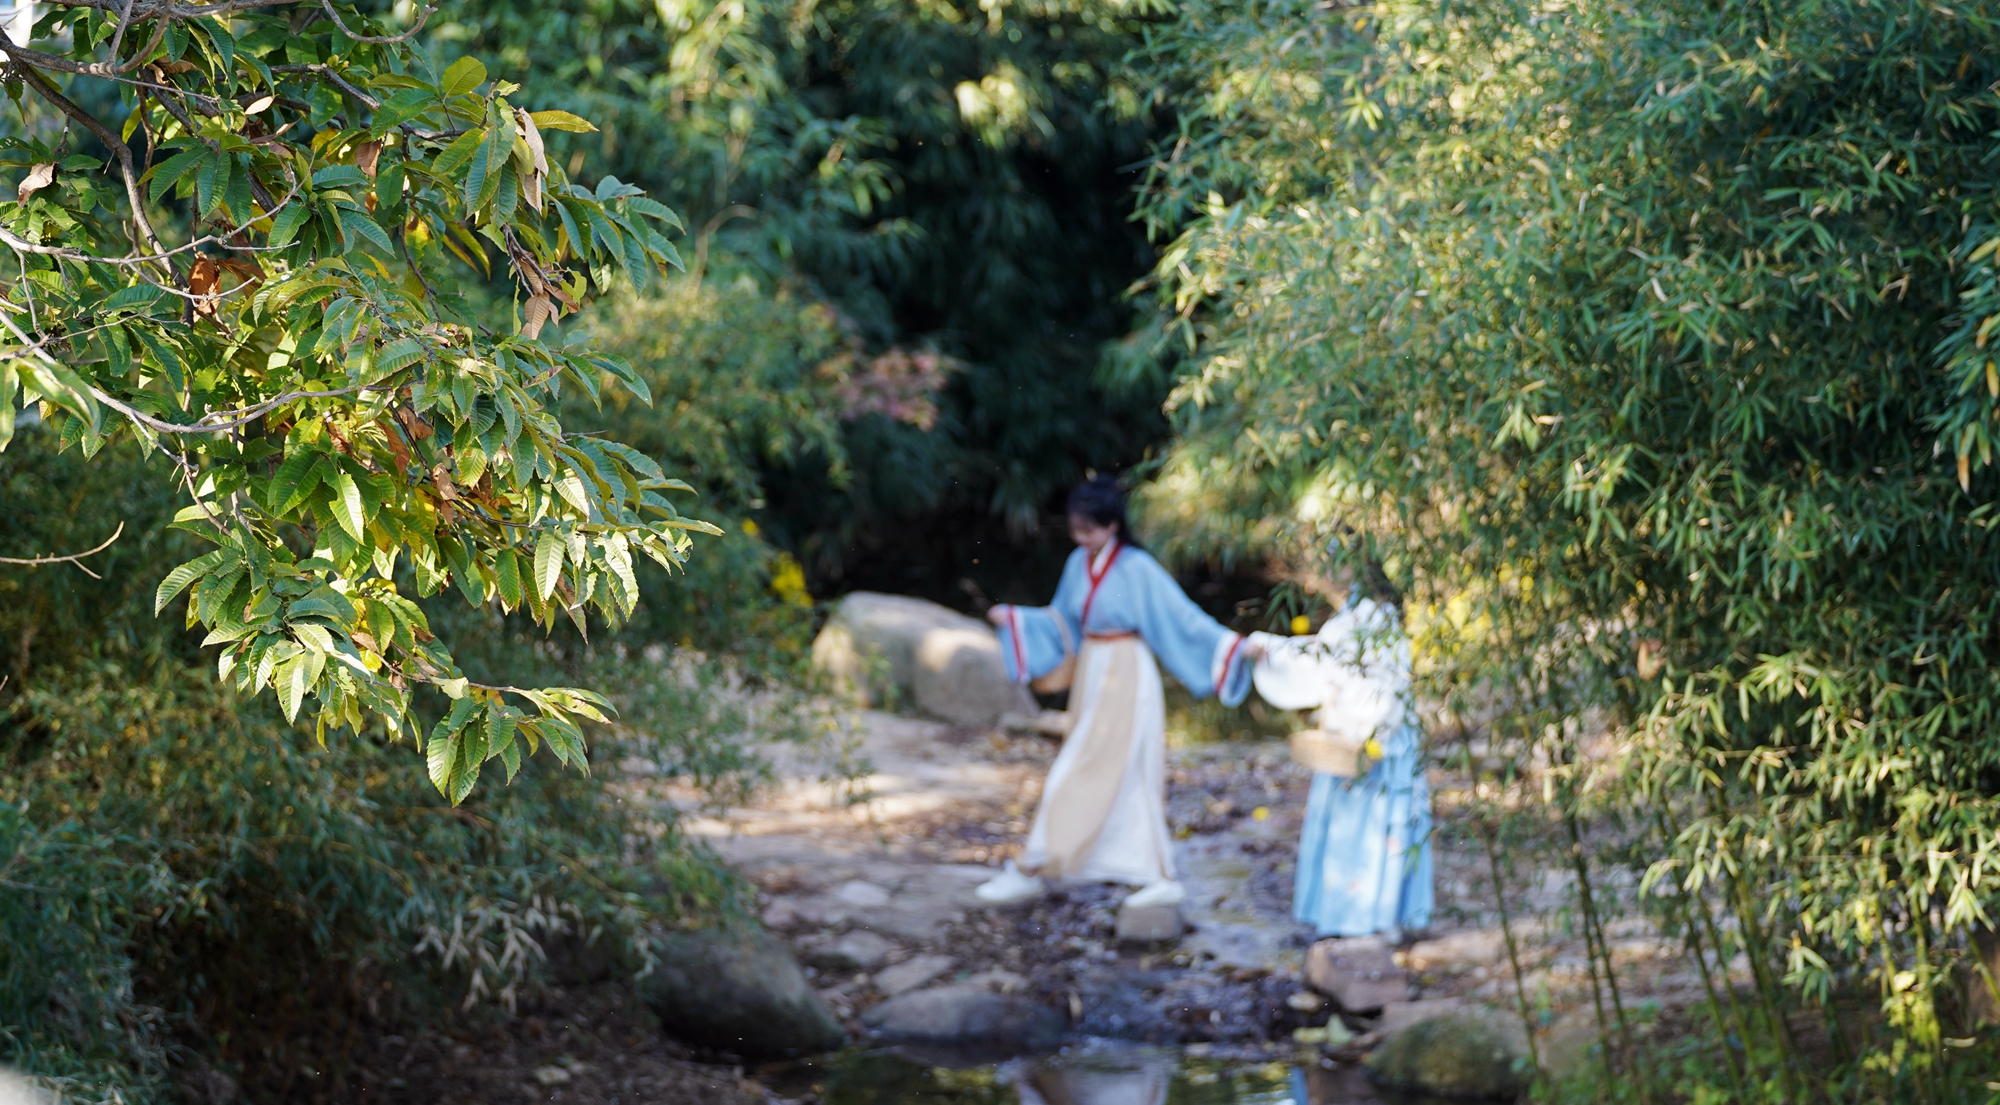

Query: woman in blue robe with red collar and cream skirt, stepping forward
[978,476,1260,907]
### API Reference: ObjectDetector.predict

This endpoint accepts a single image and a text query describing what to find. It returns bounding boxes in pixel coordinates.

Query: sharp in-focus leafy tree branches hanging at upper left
[0,0,714,803]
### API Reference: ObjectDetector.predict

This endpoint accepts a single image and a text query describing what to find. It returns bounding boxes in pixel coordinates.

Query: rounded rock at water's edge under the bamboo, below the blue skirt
[1368,1009,1530,1099]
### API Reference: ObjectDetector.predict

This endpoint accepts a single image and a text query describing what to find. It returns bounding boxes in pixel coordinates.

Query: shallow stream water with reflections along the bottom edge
[760,1041,1444,1105]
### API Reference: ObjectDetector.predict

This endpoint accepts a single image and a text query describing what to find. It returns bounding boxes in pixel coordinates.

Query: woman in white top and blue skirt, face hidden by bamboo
[1256,565,1436,941]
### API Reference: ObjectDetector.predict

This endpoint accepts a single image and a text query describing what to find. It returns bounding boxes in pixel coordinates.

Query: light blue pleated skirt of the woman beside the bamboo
[1292,727,1436,937]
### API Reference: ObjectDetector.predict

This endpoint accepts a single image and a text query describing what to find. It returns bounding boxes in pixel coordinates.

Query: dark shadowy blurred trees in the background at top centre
[434,0,1166,601]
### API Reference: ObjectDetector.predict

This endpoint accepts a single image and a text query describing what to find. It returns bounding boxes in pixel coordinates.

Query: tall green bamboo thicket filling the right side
[1140,0,2000,1101]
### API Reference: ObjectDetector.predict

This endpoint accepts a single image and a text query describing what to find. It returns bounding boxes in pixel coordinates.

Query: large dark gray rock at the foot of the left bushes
[640,927,846,1057]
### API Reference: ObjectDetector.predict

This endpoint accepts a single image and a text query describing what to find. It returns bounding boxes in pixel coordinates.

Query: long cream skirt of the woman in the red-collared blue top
[1020,637,1174,887]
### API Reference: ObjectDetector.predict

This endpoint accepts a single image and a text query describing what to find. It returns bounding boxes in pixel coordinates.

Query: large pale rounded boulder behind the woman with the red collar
[812,591,1036,725]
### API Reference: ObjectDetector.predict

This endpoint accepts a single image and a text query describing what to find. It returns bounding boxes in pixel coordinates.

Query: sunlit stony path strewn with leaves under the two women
[648,711,1700,1080]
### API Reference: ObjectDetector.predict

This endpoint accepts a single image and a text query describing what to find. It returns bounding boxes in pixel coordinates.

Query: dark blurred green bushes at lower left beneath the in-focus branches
[0,426,804,1101]
